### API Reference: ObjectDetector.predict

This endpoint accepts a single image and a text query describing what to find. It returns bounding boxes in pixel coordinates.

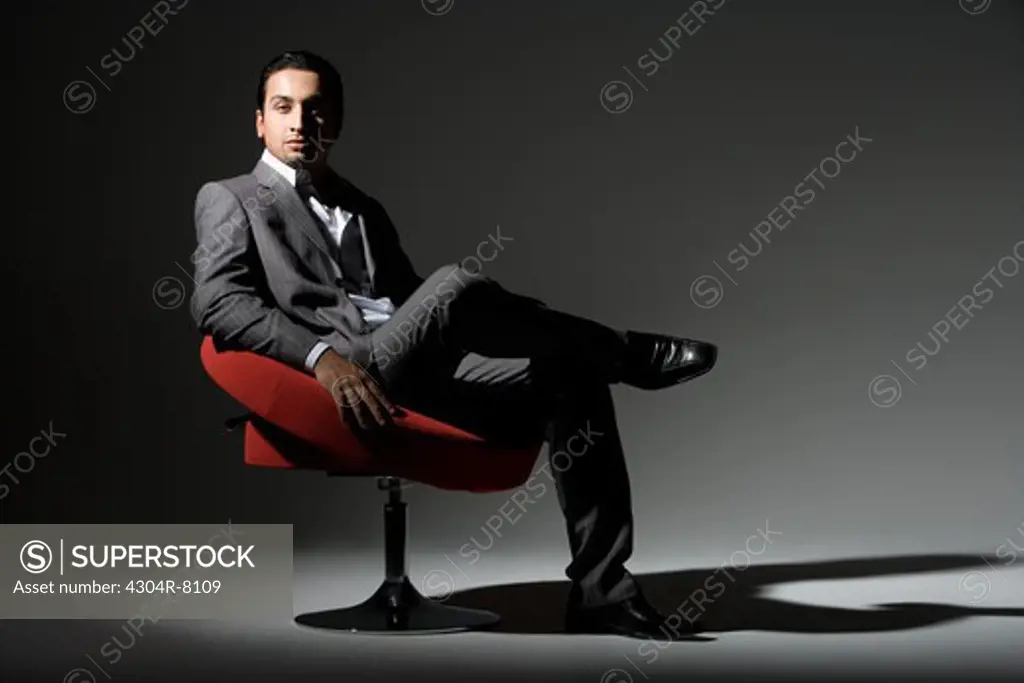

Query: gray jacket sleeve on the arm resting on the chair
[190,182,319,372]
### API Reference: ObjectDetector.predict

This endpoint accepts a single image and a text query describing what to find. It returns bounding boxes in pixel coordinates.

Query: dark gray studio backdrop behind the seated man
[0,0,1024,679]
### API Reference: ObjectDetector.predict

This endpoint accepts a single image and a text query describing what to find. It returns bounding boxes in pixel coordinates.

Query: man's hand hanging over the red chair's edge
[313,349,401,430]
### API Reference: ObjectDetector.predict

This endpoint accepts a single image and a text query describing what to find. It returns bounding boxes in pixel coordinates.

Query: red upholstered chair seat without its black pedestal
[200,335,542,492]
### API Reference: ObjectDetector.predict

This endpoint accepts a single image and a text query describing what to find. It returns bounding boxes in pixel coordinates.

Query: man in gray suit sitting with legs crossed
[191,51,717,640]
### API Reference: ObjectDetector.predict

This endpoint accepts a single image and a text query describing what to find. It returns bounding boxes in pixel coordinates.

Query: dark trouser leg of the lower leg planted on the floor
[384,352,637,606]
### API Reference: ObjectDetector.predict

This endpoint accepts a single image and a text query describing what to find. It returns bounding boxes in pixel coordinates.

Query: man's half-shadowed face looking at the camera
[256,69,338,168]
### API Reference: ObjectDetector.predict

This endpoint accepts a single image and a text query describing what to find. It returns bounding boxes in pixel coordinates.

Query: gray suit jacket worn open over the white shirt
[190,161,423,371]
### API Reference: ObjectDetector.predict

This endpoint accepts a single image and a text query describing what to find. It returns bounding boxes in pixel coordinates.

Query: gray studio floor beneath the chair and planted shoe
[0,550,1024,683]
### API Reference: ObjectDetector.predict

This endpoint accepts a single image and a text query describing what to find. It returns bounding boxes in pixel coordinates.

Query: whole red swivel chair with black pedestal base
[194,336,542,633]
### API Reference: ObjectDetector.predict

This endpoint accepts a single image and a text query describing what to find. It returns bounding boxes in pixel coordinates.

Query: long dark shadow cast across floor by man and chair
[444,555,1024,634]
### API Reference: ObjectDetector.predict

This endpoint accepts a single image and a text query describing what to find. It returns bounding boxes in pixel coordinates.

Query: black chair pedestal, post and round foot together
[295,476,501,634]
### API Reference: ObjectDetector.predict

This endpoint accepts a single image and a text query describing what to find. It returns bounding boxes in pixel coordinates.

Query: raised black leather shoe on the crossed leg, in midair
[620,330,718,389]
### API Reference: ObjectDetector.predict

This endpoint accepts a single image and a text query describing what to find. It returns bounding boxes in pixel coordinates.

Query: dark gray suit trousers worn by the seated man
[367,265,637,606]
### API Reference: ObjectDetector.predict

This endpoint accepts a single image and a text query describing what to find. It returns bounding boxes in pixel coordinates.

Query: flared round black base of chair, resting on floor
[295,577,501,635]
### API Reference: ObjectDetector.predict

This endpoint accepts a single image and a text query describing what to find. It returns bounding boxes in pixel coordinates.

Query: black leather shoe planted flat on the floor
[565,596,705,641]
